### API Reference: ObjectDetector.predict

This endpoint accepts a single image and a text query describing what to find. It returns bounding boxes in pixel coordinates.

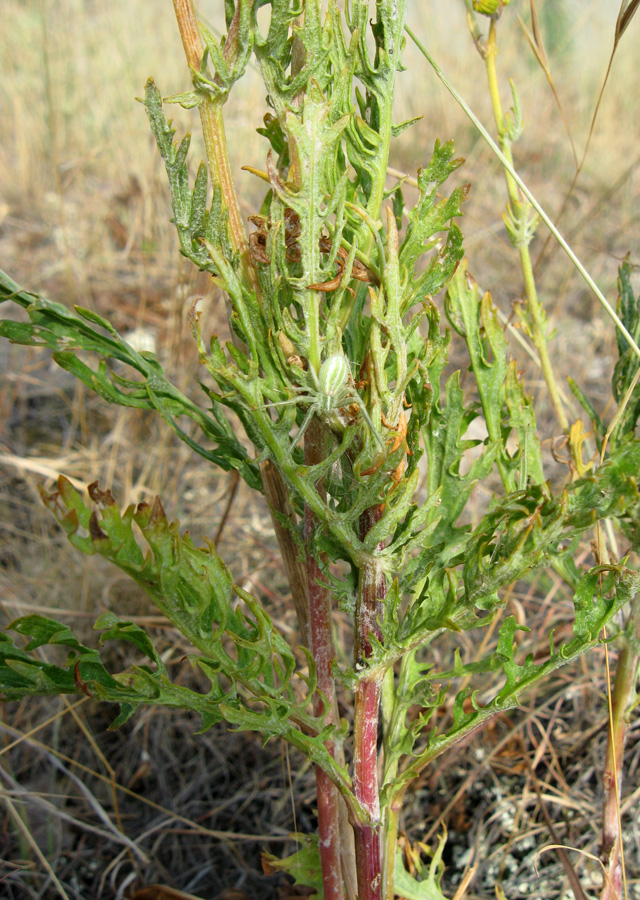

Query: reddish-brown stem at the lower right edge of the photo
[601,595,640,900]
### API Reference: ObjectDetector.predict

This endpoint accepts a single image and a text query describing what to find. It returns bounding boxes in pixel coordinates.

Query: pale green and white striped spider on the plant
[264,353,385,452]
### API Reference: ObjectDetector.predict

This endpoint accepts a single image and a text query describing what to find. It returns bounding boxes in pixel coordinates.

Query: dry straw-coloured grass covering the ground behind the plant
[0,0,640,900]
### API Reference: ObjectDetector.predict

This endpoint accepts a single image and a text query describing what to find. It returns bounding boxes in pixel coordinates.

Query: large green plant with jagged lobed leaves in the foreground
[0,0,640,900]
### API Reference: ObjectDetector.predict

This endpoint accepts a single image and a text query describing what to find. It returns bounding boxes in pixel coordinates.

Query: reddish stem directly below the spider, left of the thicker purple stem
[304,418,344,900]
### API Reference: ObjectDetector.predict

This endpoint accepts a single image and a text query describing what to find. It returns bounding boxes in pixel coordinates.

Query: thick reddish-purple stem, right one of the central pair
[353,507,386,900]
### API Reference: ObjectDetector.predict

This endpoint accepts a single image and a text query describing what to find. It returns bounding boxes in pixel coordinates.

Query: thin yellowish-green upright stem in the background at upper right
[485,19,569,434]
